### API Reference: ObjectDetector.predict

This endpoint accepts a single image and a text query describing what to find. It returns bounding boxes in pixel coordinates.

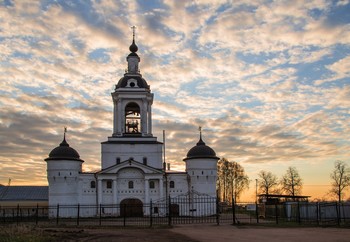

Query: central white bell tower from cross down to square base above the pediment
[102,26,162,169]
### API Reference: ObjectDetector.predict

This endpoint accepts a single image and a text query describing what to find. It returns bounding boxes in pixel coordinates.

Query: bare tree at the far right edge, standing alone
[330,161,350,202]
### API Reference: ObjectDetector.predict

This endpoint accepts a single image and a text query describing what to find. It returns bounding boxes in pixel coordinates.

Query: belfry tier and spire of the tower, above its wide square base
[112,26,153,137]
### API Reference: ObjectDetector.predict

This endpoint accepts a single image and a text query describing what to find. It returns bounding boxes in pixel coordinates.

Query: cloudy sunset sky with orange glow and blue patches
[0,0,350,201]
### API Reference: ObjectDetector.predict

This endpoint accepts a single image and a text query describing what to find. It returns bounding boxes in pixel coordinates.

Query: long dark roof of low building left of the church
[0,186,49,201]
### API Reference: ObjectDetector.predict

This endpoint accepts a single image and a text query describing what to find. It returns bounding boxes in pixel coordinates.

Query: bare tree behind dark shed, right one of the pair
[281,166,303,199]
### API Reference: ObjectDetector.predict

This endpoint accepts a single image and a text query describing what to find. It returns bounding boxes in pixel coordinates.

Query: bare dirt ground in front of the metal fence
[4,224,350,242]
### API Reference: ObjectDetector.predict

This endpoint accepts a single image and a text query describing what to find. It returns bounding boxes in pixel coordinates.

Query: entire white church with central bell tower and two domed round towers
[45,32,219,217]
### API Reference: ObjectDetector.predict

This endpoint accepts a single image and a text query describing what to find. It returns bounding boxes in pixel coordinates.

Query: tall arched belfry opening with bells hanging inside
[125,102,141,134]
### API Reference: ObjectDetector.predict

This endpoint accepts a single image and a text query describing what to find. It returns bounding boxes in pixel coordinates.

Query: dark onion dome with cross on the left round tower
[45,136,84,162]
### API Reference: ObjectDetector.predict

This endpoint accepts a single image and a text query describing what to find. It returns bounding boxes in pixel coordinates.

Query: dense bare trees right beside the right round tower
[217,158,249,202]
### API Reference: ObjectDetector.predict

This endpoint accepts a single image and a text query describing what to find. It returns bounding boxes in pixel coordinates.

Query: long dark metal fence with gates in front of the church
[0,199,350,227]
